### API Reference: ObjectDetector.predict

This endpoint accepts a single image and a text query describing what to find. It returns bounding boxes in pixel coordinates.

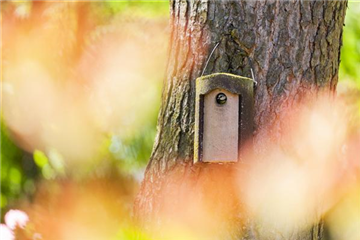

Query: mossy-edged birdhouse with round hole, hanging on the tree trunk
[194,73,254,163]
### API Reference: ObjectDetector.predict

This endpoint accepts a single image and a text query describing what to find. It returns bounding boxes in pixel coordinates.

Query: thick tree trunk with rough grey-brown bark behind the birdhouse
[135,0,347,240]
